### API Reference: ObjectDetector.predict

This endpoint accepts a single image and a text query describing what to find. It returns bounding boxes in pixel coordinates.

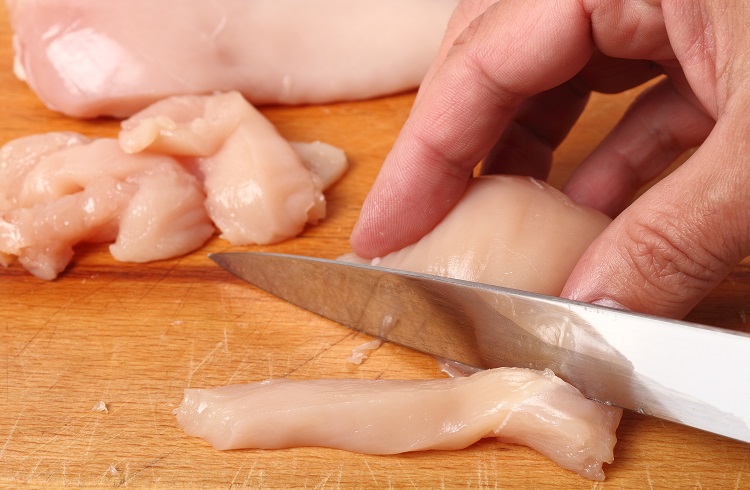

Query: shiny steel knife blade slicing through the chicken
[209,252,750,442]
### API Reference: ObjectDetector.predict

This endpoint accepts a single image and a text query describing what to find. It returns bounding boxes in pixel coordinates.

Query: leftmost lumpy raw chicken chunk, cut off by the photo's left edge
[0,133,214,279]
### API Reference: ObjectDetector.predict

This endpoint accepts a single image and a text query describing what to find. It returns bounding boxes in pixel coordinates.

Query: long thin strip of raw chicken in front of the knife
[176,368,622,480]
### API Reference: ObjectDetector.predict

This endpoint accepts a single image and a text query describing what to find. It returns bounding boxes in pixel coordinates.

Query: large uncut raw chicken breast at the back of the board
[7,0,457,117]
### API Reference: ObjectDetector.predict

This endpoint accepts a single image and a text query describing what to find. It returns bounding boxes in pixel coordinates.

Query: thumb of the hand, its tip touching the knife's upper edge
[562,119,750,318]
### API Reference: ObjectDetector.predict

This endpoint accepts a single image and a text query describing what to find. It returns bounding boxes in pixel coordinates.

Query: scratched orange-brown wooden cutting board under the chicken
[0,7,750,488]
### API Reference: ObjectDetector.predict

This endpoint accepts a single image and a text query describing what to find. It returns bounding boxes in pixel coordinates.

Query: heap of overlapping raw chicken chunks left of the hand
[0,92,347,279]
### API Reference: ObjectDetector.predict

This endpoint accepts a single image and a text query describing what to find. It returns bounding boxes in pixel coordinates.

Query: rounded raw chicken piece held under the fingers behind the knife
[341,175,611,296]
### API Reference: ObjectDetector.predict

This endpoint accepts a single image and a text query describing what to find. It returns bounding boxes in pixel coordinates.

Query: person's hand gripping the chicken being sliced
[351,0,750,318]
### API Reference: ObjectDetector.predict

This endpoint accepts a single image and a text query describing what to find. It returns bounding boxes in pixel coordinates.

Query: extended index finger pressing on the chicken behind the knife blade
[352,0,593,257]
